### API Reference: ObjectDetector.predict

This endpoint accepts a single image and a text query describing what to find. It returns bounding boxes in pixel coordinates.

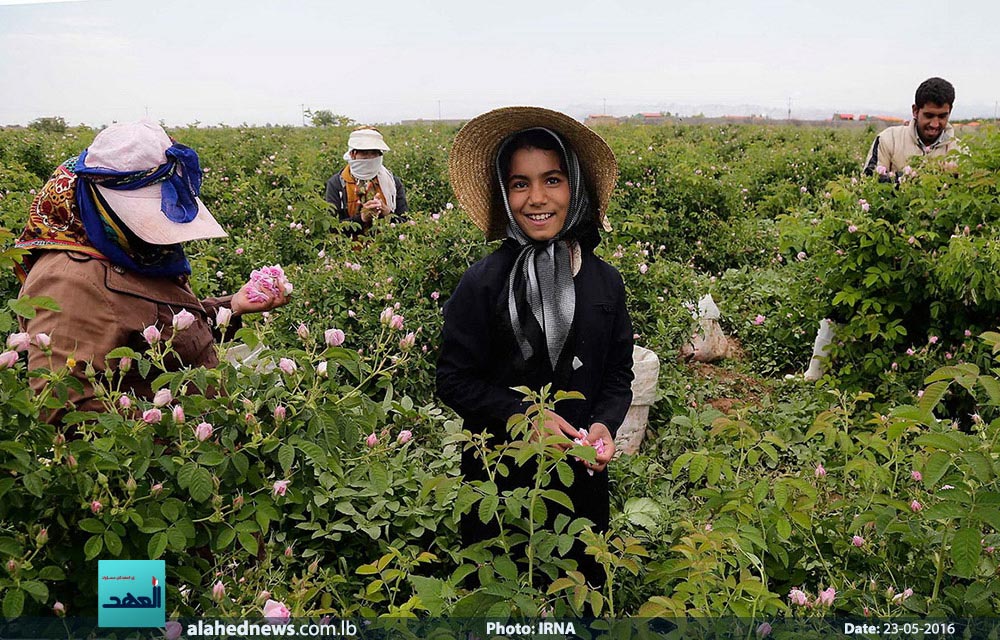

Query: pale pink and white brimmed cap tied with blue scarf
[86,120,227,244]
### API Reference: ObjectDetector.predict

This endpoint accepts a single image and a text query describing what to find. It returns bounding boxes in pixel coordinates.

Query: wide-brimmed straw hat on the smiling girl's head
[448,107,618,240]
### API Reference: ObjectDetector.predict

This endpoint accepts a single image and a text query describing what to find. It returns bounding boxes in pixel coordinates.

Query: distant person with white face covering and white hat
[324,127,406,236]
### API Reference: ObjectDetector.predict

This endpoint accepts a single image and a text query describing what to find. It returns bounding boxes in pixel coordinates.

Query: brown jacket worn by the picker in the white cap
[20,251,232,422]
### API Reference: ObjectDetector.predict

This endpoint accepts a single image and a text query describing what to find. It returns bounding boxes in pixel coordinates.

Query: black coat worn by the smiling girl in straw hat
[437,240,633,543]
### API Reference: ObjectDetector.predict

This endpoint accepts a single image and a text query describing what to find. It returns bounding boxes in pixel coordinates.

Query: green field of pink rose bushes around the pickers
[0,125,1000,622]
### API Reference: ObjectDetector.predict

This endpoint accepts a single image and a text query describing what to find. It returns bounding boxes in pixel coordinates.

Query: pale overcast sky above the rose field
[0,0,1000,126]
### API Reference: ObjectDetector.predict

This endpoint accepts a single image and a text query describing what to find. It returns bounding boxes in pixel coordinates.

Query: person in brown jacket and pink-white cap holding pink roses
[16,121,287,421]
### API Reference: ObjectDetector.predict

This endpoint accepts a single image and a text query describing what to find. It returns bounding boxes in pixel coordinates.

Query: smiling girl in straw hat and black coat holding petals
[437,107,632,583]
